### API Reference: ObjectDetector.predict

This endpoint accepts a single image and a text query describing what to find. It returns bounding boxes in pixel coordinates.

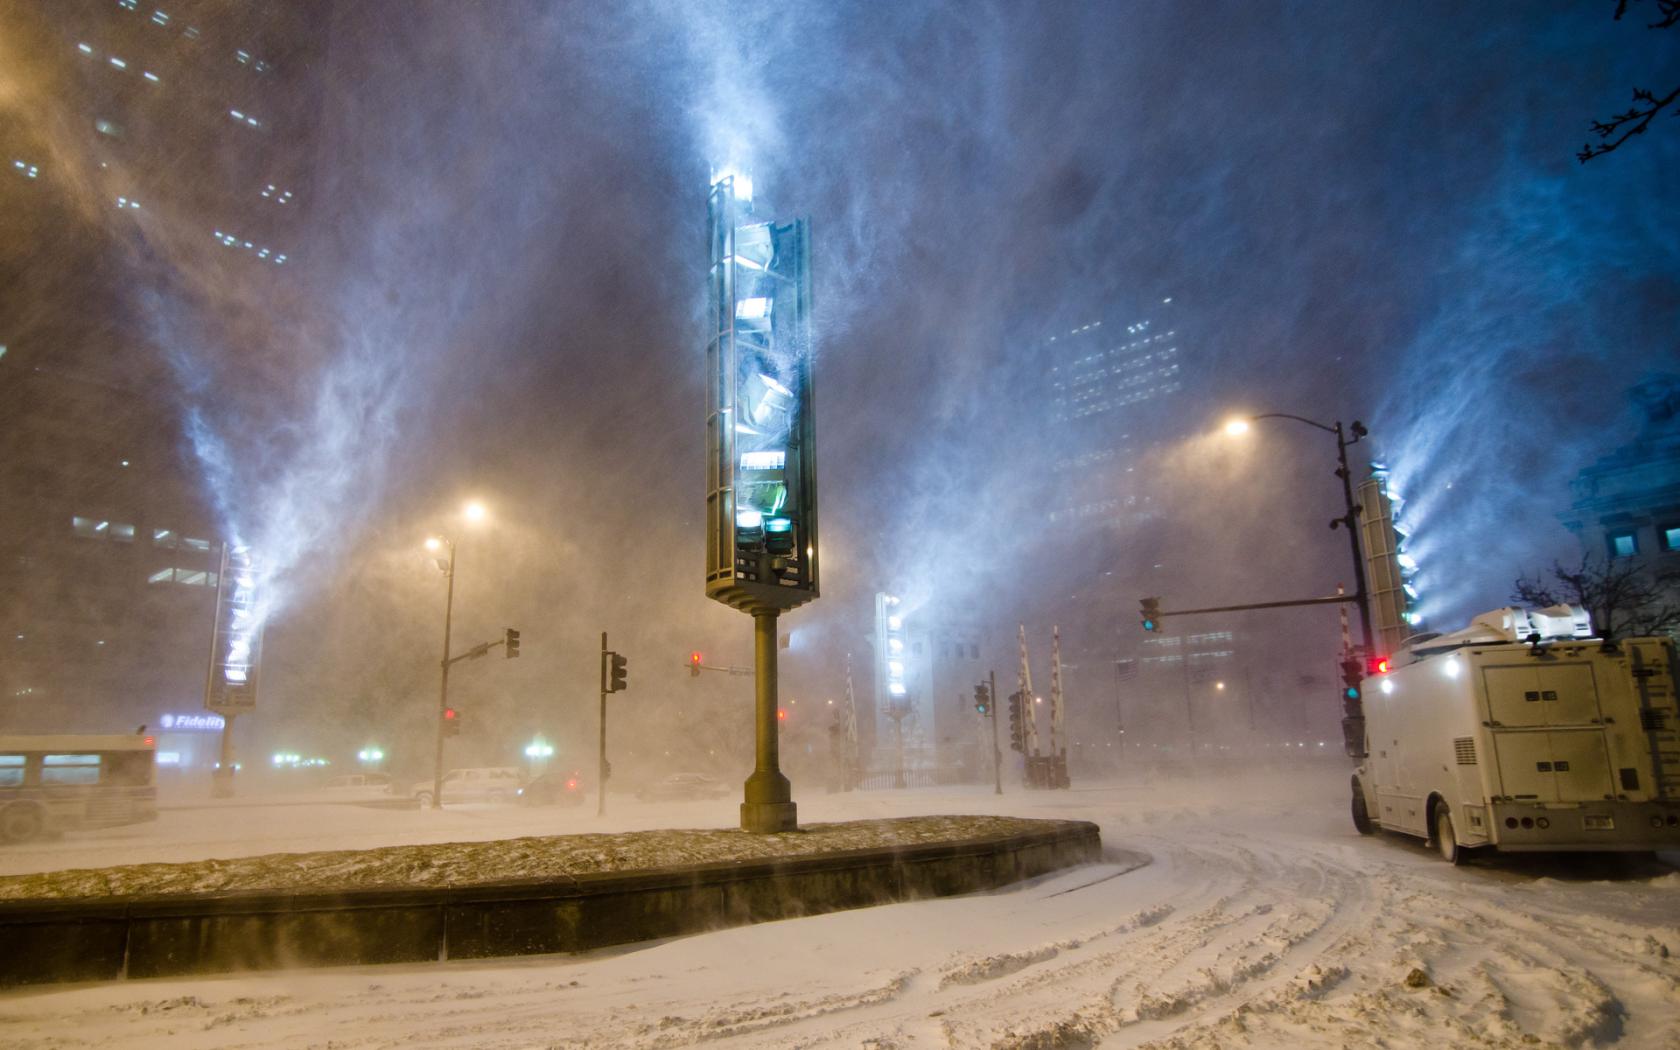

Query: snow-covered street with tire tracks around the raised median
[0,764,1680,1050]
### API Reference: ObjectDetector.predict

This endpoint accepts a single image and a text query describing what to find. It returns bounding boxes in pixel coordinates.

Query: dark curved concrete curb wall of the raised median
[0,822,1102,984]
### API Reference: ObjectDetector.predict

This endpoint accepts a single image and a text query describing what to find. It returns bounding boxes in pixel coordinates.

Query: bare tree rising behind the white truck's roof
[1510,554,1680,638]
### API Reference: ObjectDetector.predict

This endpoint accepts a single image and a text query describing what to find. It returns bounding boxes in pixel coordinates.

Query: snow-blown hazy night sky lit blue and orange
[0,2,1680,769]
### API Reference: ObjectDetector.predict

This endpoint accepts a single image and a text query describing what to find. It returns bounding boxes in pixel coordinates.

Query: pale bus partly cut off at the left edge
[0,736,158,843]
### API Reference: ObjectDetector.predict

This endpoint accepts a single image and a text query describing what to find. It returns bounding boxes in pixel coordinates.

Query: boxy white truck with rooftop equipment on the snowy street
[1352,605,1680,864]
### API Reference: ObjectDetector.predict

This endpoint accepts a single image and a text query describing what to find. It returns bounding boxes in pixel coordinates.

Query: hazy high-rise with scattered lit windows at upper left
[0,0,323,742]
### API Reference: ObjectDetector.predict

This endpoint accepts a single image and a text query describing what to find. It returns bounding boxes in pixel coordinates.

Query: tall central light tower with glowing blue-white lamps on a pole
[706,171,816,832]
